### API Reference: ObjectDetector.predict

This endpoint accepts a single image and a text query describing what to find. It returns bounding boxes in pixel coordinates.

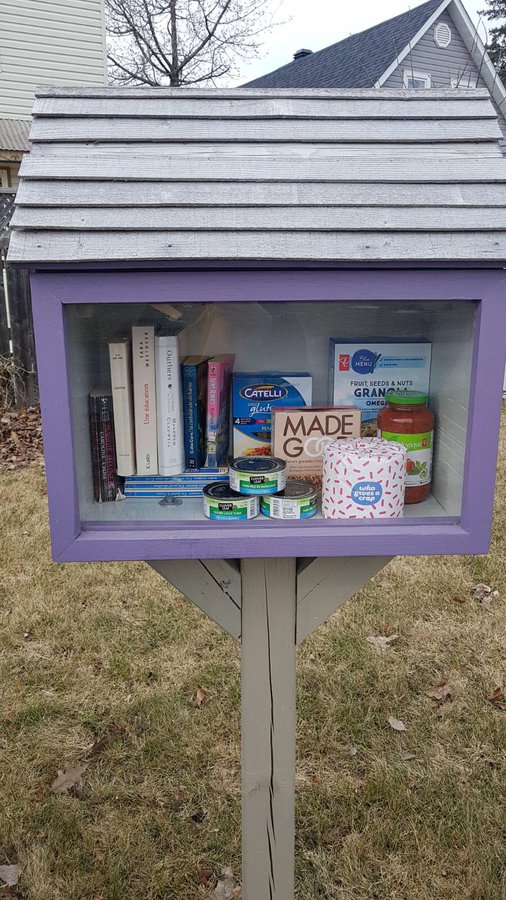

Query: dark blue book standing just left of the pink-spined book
[183,356,209,469]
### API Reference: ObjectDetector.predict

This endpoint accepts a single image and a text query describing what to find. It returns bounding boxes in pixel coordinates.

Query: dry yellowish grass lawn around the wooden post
[0,416,506,900]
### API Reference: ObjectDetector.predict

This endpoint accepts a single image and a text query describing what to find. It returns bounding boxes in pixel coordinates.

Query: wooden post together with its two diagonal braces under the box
[150,556,390,900]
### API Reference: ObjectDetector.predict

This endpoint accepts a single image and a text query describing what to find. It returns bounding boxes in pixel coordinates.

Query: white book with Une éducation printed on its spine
[132,325,158,475]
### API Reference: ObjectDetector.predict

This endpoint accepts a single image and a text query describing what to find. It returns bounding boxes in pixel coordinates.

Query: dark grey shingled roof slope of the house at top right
[244,0,441,88]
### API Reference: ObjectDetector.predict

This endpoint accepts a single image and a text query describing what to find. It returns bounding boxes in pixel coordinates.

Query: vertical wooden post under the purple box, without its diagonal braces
[241,559,297,900]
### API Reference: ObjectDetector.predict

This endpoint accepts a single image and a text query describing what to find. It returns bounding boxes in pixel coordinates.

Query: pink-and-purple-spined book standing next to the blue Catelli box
[206,353,235,466]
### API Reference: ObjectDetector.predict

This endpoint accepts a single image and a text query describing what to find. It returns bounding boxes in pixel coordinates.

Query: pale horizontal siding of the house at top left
[0,0,106,119]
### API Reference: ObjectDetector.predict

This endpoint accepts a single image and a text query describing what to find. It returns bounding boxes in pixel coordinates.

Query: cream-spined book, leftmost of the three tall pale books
[109,340,135,476]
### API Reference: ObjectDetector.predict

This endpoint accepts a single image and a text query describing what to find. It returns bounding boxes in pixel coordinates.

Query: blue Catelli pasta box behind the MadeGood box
[232,372,312,457]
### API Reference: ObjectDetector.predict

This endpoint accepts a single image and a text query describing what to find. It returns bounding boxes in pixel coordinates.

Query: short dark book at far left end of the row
[89,388,120,503]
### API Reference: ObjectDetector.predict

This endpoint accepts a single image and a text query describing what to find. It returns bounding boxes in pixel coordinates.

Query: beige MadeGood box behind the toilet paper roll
[272,406,360,488]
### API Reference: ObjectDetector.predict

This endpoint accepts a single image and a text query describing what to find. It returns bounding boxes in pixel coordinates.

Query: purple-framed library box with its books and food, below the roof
[30,271,503,559]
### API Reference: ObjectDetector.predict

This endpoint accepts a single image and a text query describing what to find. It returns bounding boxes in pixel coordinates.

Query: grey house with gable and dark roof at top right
[243,0,506,139]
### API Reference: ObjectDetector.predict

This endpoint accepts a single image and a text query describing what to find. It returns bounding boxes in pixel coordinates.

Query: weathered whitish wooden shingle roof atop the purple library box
[6,88,506,263]
